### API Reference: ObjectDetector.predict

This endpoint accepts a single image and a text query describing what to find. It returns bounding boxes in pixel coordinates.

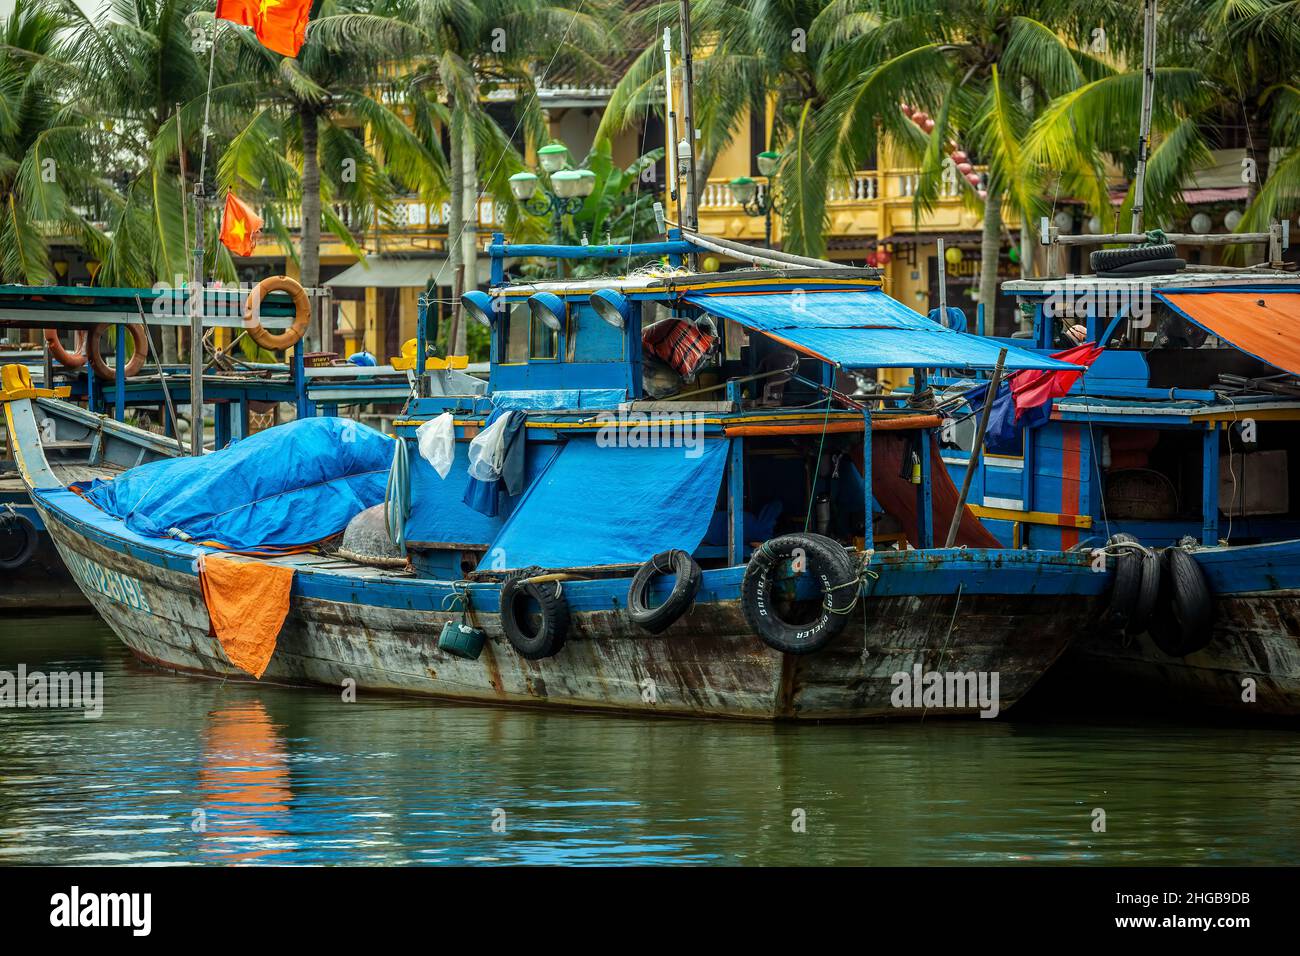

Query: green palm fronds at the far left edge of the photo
[0,0,105,285]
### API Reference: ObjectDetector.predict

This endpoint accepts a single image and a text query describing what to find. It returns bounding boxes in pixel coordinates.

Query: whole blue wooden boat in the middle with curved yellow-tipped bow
[4,237,1112,719]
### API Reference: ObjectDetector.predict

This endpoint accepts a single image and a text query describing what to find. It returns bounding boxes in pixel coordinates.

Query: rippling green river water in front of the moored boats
[0,618,1300,865]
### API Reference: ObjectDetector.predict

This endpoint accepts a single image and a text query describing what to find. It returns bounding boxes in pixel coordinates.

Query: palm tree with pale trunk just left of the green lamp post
[384,0,608,354]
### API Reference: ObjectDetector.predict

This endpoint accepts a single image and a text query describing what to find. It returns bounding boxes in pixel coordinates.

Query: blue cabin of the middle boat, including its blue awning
[397,227,1073,576]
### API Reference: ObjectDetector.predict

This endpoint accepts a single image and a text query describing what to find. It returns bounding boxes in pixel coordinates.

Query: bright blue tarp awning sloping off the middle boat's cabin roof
[685,289,1074,371]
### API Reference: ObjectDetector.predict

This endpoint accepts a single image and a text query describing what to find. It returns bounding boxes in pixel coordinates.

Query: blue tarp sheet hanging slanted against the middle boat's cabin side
[484,438,731,570]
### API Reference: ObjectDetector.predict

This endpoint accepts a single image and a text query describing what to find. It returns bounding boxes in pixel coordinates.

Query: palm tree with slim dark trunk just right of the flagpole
[217,0,445,351]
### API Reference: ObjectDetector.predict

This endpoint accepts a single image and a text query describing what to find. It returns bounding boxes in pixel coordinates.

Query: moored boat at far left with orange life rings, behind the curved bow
[0,285,421,613]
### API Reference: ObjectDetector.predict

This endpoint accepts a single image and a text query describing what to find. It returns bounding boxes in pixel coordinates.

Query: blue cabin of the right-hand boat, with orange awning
[943,269,1300,548]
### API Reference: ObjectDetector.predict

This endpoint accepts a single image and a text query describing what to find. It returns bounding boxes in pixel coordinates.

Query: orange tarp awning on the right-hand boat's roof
[1157,293,1300,375]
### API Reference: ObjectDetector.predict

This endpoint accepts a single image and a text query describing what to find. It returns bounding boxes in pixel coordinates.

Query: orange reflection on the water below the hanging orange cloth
[199,700,293,864]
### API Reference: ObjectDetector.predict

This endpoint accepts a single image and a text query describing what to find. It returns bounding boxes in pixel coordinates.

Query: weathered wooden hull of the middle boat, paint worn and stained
[35,502,1096,719]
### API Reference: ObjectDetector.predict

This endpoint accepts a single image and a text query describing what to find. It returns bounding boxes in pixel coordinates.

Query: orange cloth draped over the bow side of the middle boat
[199,554,294,678]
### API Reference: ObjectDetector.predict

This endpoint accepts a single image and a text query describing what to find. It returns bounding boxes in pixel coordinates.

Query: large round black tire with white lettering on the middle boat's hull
[741,535,858,654]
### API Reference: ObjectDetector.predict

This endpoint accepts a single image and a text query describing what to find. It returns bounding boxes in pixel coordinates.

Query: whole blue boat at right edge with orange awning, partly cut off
[943,251,1300,717]
